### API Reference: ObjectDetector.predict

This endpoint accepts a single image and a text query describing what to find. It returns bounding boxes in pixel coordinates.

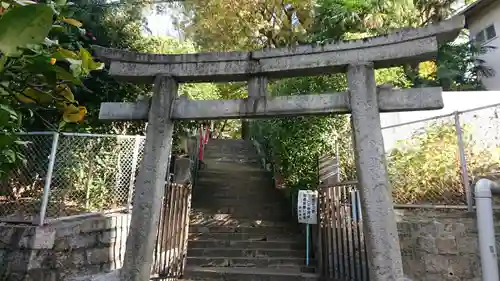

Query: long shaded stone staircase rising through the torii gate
[184,140,317,281]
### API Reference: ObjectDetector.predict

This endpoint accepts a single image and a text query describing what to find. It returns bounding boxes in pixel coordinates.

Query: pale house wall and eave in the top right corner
[467,1,500,91]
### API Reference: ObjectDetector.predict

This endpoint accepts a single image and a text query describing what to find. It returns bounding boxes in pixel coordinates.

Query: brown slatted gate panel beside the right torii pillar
[314,182,369,281]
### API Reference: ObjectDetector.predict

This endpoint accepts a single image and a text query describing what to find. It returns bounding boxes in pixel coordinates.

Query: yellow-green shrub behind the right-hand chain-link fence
[387,122,500,204]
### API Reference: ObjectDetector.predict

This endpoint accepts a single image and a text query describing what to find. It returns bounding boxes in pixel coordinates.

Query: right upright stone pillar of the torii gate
[347,63,403,281]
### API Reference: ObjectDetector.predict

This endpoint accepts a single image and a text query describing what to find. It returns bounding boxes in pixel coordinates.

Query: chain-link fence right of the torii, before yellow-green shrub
[383,105,500,207]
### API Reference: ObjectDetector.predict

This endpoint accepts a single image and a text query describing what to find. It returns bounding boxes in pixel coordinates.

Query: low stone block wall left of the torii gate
[0,214,130,281]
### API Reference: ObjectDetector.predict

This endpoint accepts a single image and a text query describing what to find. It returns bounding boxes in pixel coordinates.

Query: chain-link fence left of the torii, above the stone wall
[0,132,145,223]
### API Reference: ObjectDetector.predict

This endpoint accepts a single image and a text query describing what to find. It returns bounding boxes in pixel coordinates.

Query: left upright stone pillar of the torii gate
[120,76,178,281]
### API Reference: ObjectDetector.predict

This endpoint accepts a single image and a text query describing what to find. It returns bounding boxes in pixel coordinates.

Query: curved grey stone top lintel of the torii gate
[93,16,465,83]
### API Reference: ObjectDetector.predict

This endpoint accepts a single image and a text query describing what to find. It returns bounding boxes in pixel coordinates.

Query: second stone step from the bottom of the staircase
[187,256,305,268]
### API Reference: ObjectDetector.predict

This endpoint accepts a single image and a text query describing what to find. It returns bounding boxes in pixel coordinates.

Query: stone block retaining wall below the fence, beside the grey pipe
[397,209,494,281]
